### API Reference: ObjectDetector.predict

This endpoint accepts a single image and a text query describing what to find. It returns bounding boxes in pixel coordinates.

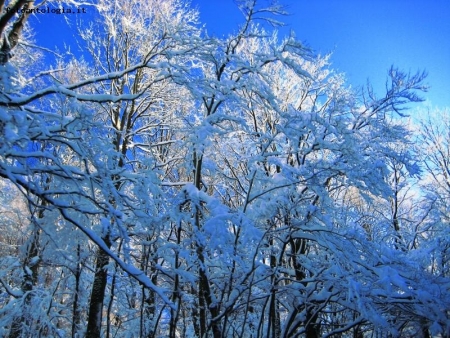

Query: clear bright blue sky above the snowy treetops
[31,0,450,107]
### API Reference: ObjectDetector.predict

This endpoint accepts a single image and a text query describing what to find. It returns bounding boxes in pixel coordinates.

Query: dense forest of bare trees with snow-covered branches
[0,0,450,338]
